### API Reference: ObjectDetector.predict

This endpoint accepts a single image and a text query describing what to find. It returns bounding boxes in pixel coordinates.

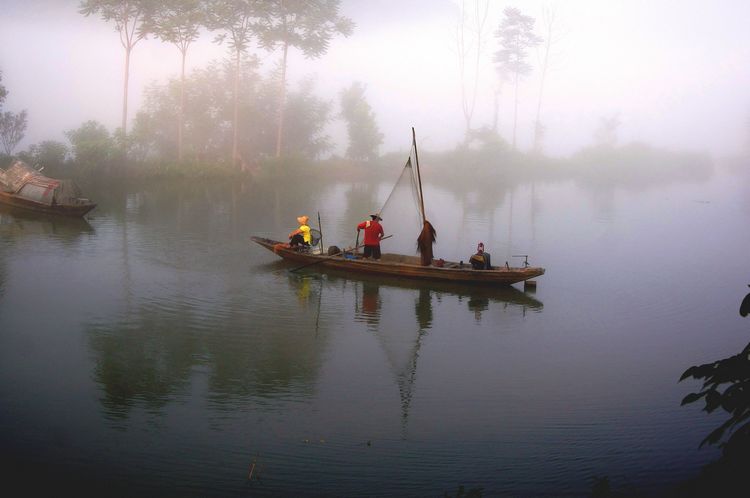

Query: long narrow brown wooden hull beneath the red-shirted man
[251,236,544,286]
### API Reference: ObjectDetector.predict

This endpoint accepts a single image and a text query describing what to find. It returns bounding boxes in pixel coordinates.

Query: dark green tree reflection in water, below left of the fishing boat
[88,277,327,420]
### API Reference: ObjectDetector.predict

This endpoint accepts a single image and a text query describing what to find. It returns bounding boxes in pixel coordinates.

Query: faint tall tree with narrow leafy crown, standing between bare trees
[494,7,542,148]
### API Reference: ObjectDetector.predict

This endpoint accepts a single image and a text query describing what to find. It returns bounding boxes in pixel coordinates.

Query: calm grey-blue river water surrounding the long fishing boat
[0,161,750,496]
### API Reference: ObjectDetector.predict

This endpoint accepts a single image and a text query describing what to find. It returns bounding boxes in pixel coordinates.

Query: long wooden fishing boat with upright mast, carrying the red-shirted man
[251,128,544,286]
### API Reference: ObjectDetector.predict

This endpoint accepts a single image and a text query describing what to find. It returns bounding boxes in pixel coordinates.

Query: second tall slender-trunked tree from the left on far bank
[153,0,206,161]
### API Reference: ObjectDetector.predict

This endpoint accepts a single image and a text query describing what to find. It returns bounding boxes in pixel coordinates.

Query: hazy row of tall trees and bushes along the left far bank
[3,0,382,176]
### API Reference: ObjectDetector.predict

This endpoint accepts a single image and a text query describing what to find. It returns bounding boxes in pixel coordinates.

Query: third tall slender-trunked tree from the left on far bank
[207,0,267,168]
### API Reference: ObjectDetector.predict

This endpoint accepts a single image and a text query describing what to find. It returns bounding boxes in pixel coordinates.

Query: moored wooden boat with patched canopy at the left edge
[0,161,96,217]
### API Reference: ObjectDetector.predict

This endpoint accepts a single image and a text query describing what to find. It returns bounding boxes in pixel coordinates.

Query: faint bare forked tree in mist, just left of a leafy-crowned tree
[456,0,489,142]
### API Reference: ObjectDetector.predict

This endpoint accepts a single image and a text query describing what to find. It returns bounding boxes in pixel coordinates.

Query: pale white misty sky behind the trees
[0,0,750,155]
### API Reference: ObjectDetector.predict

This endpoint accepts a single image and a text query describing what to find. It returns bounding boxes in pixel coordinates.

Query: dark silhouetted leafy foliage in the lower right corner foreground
[679,288,750,496]
